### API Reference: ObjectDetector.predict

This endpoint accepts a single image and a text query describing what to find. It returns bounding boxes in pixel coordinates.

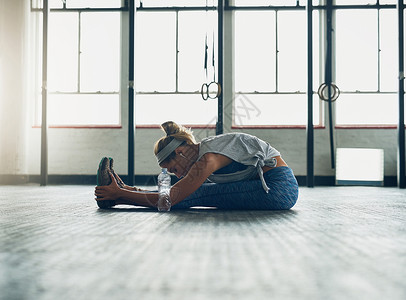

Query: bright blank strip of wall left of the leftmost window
[0,0,29,174]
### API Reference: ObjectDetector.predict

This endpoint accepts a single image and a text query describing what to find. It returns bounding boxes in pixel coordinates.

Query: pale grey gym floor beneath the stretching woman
[0,186,406,300]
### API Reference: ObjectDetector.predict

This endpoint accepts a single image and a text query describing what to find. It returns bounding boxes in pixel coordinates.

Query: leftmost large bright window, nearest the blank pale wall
[31,0,120,127]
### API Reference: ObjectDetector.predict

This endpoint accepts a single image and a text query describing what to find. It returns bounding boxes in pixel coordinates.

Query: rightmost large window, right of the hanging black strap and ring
[335,6,398,126]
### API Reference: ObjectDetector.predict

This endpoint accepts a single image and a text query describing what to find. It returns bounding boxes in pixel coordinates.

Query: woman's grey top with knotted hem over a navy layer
[198,133,280,192]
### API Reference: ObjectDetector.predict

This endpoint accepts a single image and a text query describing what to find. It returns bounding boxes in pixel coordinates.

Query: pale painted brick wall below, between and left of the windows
[0,0,397,182]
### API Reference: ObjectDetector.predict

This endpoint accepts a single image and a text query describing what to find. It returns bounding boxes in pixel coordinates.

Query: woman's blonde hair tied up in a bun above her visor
[154,121,196,161]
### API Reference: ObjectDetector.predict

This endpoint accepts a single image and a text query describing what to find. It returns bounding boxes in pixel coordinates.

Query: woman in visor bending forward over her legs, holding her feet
[95,121,298,210]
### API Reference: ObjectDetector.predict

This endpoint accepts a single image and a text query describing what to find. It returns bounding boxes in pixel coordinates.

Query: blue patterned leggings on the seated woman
[172,167,299,210]
